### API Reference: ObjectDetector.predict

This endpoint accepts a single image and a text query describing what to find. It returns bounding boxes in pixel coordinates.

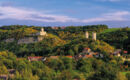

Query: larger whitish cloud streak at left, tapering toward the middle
[0,7,76,22]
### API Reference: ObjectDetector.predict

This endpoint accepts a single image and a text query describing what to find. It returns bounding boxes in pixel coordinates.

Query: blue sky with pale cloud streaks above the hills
[0,0,130,27]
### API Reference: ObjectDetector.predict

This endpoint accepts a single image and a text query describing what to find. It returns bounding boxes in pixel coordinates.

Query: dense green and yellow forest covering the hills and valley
[0,25,130,80]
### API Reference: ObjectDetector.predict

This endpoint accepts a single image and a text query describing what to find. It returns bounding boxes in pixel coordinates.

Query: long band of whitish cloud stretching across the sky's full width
[0,7,130,23]
